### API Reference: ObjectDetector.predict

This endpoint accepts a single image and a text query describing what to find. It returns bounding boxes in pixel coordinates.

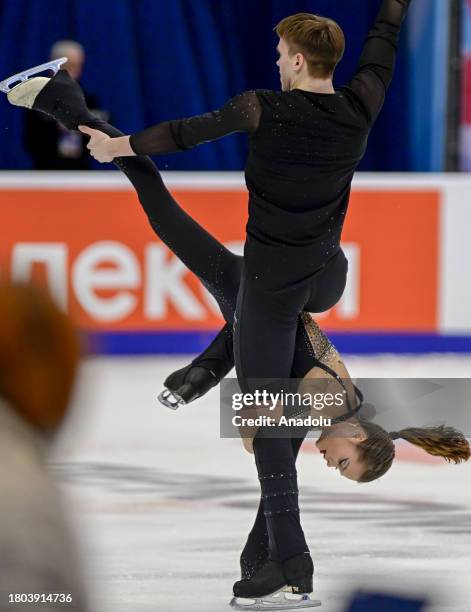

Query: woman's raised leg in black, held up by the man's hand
[11,70,242,323]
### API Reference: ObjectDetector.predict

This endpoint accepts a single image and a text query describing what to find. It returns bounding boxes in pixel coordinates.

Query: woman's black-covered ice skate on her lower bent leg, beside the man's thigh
[158,363,219,410]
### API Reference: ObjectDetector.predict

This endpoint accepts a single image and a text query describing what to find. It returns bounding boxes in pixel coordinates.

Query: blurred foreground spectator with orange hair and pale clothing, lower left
[0,284,86,612]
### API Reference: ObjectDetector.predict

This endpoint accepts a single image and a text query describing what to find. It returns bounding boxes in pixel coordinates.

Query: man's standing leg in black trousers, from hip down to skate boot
[234,270,309,563]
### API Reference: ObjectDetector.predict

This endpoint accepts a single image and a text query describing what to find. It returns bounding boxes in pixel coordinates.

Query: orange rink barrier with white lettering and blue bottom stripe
[0,172,471,354]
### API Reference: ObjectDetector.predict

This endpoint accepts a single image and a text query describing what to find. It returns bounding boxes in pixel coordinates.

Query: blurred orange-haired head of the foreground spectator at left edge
[0,283,80,433]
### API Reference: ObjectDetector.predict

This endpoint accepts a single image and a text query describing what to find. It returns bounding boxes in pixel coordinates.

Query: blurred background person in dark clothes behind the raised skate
[24,40,108,170]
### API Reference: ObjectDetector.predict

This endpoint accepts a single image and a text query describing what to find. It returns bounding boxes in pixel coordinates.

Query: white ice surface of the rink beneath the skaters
[52,355,471,612]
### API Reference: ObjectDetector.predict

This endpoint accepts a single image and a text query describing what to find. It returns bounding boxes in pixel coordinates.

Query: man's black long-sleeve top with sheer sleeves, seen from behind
[131,0,410,289]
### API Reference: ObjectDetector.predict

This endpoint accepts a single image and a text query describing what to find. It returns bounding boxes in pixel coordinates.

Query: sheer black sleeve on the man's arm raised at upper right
[345,0,410,123]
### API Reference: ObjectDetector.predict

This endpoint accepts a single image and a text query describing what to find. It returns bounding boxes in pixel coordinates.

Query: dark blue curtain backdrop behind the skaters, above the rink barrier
[0,0,420,170]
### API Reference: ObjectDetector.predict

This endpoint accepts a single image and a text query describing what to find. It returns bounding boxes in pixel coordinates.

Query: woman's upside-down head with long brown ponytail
[316,420,471,482]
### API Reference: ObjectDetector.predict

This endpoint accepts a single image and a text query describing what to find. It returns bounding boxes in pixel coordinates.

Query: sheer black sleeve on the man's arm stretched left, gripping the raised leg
[130,91,262,155]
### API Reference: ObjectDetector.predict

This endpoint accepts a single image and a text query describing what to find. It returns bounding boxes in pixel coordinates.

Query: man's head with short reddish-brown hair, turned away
[275,13,345,91]
